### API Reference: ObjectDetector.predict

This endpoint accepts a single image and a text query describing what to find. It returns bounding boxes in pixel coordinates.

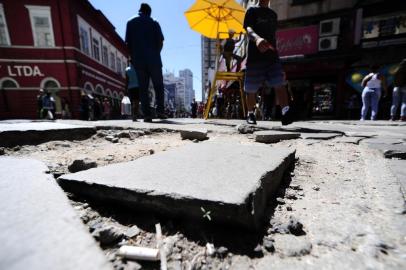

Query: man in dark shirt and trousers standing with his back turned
[125,3,167,122]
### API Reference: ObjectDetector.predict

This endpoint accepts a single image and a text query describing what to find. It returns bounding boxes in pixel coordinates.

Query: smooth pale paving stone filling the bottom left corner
[0,157,112,270]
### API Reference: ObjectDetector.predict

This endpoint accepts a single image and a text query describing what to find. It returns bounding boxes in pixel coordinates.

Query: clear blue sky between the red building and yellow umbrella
[89,0,202,100]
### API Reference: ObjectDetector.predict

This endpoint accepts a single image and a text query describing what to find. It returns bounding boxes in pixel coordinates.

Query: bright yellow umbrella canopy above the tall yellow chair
[185,0,245,39]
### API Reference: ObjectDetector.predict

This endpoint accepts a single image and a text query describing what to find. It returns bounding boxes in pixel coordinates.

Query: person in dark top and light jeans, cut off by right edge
[391,59,406,121]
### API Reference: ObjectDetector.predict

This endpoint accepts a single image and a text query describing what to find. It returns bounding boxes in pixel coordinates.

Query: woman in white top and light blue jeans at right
[361,65,388,121]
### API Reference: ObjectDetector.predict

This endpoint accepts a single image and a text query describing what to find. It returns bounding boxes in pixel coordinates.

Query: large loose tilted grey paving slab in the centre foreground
[58,143,295,229]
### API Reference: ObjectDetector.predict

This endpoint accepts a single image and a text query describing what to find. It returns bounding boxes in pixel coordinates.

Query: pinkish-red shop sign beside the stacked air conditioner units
[276,25,319,56]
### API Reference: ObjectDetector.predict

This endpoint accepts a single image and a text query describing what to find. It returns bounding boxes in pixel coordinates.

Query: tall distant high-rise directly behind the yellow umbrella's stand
[201,37,216,101]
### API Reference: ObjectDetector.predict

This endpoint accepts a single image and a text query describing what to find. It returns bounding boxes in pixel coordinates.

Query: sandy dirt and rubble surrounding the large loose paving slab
[4,127,406,269]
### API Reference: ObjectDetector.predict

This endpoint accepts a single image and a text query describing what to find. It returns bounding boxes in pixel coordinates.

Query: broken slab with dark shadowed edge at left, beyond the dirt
[0,122,96,147]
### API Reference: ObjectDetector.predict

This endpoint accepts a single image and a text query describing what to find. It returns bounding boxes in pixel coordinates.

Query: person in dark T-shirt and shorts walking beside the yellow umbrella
[244,0,293,125]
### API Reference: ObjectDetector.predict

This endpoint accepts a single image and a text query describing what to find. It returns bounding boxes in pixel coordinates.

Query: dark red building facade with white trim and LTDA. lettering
[0,0,128,119]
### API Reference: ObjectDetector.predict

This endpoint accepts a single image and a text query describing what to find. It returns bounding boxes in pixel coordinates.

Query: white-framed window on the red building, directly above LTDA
[26,6,55,47]
